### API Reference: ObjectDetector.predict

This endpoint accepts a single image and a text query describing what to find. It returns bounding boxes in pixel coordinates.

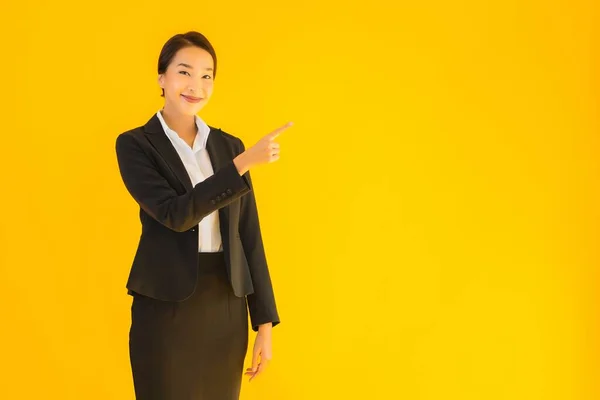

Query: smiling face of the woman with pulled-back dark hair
[158,46,214,115]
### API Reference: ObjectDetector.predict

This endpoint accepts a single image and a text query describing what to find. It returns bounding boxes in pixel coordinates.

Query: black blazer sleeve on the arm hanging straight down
[239,139,280,332]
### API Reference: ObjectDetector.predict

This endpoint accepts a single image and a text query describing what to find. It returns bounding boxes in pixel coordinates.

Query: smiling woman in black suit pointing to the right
[116,32,291,400]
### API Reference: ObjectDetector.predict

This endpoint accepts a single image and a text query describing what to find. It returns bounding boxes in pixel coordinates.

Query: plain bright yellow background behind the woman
[0,0,600,400]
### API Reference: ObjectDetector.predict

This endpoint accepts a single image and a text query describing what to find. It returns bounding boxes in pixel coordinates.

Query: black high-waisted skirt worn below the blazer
[129,252,248,400]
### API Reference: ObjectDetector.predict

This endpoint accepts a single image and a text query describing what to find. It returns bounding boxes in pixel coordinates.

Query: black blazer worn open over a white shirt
[116,114,279,331]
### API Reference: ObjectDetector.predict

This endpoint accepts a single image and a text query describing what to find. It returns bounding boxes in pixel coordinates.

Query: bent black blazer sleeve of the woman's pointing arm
[116,133,251,232]
